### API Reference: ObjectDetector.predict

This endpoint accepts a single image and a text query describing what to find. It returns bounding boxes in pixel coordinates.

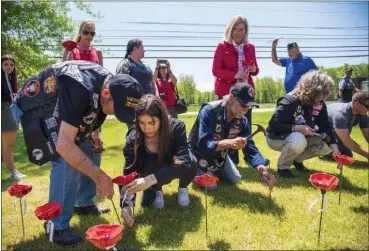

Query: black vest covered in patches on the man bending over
[16,61,111,165]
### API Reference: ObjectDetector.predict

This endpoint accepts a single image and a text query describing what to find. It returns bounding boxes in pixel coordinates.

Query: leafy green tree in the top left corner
[1,1,99,81]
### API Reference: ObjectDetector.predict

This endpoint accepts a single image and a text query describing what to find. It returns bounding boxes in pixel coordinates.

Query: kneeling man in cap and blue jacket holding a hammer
[189,83,276,190]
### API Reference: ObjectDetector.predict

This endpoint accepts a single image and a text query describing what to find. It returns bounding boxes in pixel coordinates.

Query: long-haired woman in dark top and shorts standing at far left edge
[1,55,27,181]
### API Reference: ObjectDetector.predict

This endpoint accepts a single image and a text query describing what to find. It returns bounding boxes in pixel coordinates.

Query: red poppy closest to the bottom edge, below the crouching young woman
[86,224,123,249]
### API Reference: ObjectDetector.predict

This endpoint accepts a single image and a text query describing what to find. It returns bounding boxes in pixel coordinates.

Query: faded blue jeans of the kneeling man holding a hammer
[197,155,241,191]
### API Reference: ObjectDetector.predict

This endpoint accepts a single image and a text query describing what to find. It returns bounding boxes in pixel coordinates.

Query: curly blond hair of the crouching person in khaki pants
[293,70,333,105]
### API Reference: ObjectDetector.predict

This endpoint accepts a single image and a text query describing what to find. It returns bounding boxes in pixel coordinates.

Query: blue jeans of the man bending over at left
[49,140,101,230]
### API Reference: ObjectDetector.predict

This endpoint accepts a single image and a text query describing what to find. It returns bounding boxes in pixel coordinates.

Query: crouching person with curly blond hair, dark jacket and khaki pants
[267,71,339,178]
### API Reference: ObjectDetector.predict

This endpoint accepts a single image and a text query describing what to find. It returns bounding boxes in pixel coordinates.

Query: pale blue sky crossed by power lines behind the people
[70,2,368,91]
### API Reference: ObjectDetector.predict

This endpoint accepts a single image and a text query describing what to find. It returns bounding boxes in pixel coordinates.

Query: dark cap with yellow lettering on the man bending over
[109,74,143,123]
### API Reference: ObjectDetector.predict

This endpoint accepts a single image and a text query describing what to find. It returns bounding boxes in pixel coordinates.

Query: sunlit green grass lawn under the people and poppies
[1,112,369,250]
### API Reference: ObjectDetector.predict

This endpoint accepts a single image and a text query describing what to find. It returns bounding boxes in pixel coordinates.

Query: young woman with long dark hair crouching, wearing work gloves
[121,95,196,226]
